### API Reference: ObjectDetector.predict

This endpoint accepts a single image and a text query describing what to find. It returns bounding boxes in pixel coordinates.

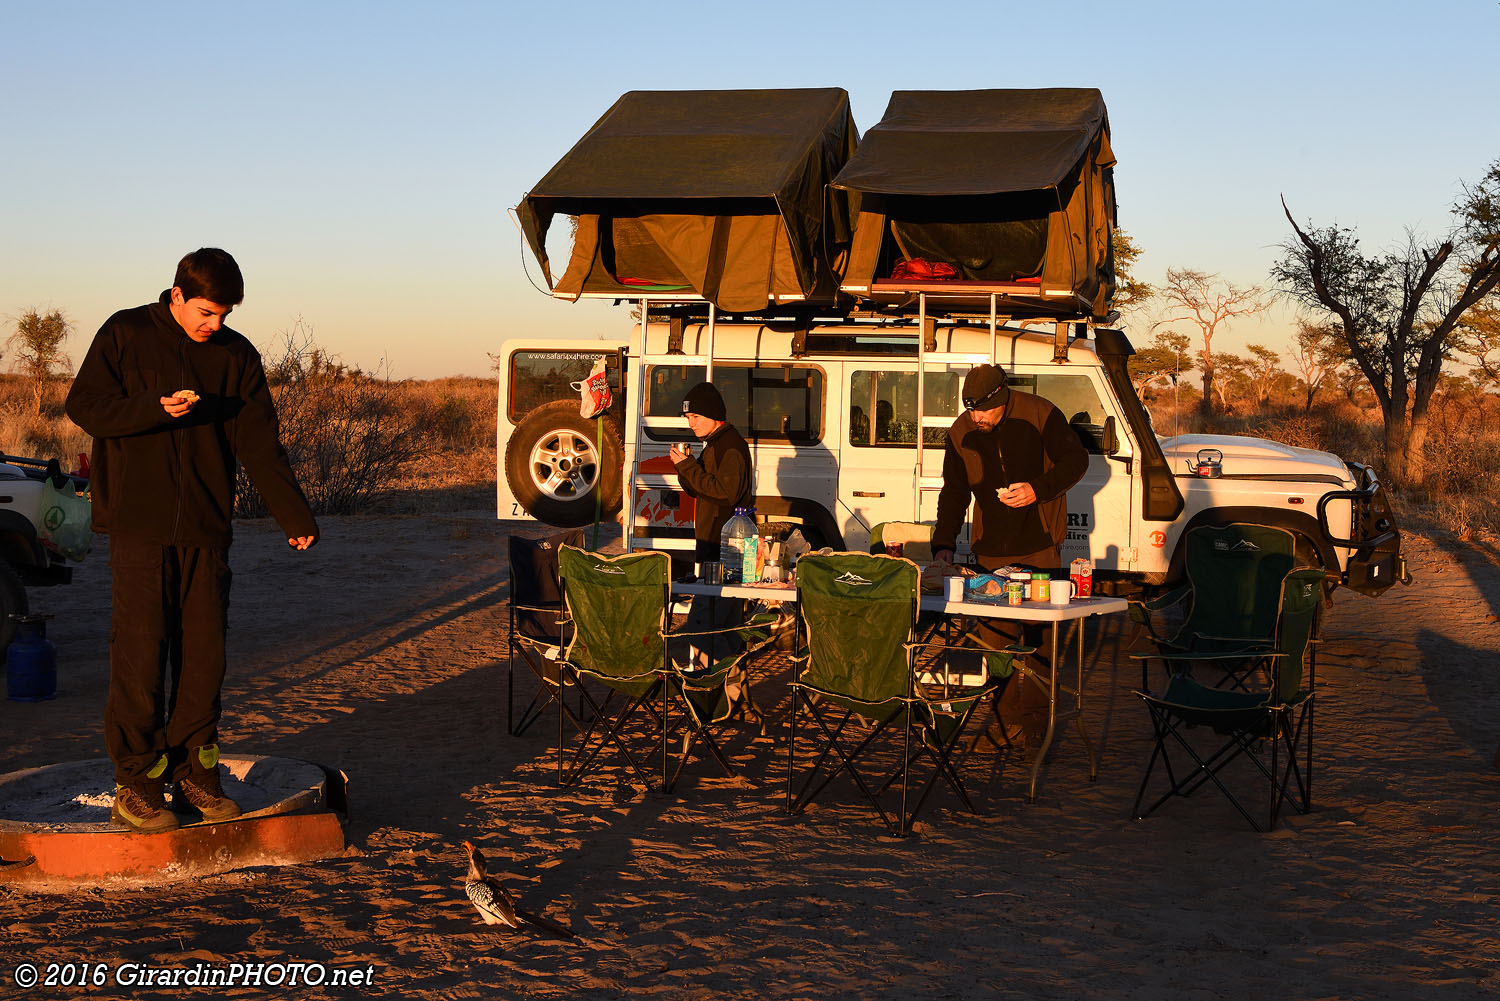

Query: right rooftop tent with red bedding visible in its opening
[834,89,1115,317]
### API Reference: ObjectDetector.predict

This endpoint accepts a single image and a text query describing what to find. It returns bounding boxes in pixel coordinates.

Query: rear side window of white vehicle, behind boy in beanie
[647,363,824,444]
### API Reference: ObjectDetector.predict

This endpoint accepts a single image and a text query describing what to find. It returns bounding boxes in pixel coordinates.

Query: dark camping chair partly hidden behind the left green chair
[506,528,584,737]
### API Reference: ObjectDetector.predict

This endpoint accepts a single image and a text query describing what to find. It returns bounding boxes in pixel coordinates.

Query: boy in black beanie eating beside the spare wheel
[671,383,755,663]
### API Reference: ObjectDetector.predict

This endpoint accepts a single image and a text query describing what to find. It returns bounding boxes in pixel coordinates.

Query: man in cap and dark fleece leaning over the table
[933,365,1089,740]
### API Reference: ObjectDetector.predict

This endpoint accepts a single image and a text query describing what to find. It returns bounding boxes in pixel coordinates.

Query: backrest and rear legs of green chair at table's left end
[555,546,672,786]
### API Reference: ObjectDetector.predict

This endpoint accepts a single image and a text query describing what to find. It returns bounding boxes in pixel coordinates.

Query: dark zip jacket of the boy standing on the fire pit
[68,293,318,548]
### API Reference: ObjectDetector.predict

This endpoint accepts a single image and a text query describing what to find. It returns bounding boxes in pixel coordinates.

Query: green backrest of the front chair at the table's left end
[558,546,672,678]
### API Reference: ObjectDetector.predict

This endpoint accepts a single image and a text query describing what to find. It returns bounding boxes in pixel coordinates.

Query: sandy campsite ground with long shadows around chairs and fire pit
[0,512,1500,1001]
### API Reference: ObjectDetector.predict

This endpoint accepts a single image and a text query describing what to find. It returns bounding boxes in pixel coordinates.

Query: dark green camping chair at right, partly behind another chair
[1130,524,1296,689]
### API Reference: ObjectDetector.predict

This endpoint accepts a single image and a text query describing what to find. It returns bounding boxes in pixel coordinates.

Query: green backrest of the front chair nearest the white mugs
[797,552,920,704]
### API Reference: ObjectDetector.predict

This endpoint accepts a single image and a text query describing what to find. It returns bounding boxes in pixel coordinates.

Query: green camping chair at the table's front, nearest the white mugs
[786,552,995,836]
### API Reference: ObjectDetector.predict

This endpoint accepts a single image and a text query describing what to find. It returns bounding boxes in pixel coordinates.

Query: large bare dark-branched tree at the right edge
[1272,159,1500,483]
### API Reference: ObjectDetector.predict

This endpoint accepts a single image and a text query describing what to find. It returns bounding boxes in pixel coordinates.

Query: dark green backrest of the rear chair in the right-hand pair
[1178,524,1296,645]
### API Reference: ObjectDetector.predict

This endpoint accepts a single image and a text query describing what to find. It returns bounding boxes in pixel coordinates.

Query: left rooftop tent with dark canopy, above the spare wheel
[519,89,858,312]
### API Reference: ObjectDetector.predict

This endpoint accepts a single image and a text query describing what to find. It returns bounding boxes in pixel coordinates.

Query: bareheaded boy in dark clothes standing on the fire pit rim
[68,248,318,831]
